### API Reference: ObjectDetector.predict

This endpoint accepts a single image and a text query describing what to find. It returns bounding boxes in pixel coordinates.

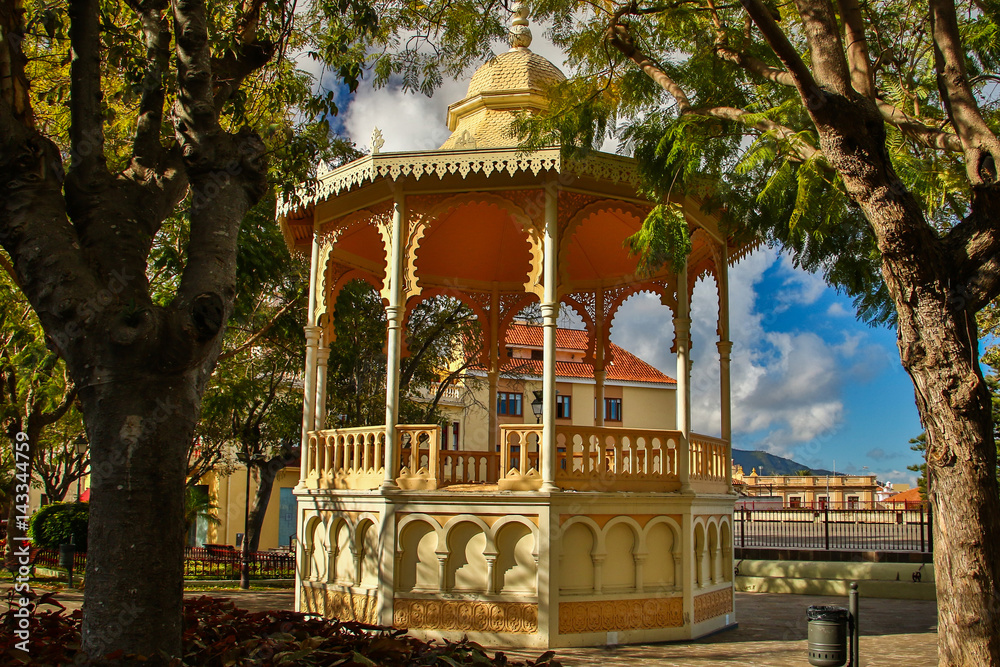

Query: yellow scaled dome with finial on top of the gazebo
[441,3,566,150]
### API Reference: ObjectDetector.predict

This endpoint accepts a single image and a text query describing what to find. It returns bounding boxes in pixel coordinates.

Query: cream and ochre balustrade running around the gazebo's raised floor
[306,424,729,492]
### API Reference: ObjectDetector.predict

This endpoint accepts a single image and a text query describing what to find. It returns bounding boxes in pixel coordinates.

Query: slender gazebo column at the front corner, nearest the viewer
[541,182,559,491]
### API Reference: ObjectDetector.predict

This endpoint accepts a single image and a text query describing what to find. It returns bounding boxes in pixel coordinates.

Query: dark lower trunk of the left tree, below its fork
[80,372,200,664]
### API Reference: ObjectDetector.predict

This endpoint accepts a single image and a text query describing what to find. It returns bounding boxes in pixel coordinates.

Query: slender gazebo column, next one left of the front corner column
[382,191,407,489]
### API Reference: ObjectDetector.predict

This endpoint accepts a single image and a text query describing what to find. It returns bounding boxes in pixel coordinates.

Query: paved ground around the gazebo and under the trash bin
[0,586,938,667]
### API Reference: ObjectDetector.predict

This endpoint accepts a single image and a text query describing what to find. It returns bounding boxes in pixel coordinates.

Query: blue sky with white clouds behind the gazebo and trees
[320,29,922,484]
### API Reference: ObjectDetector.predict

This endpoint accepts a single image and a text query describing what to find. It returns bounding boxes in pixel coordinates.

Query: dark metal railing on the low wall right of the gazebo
[733,507,934,553]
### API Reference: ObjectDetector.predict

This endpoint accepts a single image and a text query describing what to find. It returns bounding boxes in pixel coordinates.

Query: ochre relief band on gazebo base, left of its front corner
[392,598,538,634]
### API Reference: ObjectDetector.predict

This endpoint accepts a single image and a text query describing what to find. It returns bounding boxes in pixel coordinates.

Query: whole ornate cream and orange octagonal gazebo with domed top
[278,9,740,647]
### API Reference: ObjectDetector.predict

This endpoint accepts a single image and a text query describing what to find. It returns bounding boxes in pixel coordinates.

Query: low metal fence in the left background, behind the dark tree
[34,547,295,579]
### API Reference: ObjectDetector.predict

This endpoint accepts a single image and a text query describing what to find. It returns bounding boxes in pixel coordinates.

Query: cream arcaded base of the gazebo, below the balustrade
[296,432,735,648]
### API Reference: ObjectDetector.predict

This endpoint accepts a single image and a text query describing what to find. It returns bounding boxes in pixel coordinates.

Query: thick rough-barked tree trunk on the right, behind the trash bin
[814,95,1000,667]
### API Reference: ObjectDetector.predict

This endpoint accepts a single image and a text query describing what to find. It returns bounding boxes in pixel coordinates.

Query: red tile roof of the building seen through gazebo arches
[503,324,677,384]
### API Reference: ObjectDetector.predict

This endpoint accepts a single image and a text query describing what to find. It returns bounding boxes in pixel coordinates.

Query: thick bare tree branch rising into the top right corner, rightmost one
[930,0,1000,187]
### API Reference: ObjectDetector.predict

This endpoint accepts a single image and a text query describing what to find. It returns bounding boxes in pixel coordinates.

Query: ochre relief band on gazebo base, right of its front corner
[559,598,684,635]
